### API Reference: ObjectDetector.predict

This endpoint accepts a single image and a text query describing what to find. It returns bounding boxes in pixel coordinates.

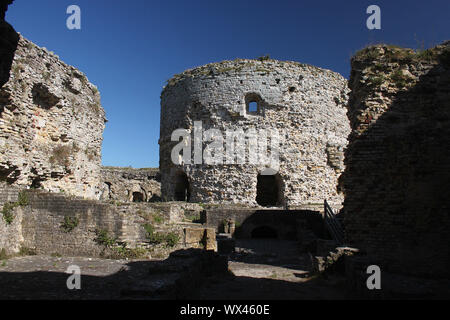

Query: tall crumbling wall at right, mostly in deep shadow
[343,42,450,277]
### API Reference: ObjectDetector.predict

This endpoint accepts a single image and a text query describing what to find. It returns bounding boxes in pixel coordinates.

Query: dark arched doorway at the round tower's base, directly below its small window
[256,175,281,207]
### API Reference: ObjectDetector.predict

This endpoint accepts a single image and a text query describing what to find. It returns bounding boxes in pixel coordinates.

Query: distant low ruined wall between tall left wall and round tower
[101,167,161,202]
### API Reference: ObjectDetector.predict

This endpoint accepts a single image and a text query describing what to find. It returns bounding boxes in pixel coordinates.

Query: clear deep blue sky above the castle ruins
[6,0,450,168]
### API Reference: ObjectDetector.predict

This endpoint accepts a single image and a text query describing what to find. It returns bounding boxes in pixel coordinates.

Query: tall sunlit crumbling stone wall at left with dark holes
[0,37,106,199]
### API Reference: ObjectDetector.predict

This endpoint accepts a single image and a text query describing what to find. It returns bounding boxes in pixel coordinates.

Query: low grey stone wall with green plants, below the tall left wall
[0,183,200,257]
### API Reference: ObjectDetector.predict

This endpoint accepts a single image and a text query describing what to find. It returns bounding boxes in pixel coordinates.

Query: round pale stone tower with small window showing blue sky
[159,59,350,207]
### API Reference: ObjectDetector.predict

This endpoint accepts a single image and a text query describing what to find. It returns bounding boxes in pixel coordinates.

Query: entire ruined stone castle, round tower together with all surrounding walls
[0,1,450,300]
